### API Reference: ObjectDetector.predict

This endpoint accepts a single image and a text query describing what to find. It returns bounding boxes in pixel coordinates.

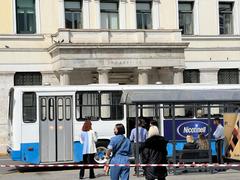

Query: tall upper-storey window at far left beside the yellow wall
[16,0,36,34]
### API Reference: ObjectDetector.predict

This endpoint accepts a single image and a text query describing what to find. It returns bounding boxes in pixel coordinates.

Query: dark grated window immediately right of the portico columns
[183,69,200,83]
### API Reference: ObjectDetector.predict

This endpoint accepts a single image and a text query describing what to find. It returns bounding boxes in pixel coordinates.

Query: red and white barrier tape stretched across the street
[0,163,240,168]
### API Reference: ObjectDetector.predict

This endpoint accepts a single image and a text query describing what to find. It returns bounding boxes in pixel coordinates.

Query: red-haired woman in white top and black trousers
[79,119,97,179]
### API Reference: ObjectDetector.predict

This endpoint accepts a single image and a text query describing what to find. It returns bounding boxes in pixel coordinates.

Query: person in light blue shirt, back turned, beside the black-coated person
[130,119,148,175]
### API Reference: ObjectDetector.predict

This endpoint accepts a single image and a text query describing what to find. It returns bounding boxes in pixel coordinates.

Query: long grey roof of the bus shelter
[121,88,240,104]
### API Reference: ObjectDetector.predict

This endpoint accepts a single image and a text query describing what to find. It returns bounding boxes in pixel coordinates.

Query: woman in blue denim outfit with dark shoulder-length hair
[107,124,131,180]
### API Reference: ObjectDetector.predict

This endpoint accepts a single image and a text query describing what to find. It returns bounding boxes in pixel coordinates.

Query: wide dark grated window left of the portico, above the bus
[14,72,42,86]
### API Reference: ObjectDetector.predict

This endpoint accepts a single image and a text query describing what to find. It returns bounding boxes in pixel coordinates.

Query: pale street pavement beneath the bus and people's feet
[0,156,240,180]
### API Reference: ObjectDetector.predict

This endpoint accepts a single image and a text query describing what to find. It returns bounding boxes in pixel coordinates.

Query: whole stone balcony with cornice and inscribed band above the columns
[48,29,188,70]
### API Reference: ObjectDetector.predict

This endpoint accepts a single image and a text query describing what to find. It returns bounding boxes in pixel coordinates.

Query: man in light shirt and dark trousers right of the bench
[213,117,225,164]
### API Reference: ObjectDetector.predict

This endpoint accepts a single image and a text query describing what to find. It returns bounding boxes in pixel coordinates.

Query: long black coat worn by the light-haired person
[141,135,168,180]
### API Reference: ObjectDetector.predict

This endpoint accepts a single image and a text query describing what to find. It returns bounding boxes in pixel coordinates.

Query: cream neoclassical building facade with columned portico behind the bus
[0,0,240,152]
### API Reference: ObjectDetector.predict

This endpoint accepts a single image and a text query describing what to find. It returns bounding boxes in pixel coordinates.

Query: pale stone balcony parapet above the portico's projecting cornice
[52,29,184,45]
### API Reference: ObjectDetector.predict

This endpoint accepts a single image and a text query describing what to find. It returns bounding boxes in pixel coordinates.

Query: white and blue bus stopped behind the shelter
[8,84,240,164]
